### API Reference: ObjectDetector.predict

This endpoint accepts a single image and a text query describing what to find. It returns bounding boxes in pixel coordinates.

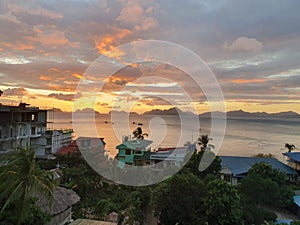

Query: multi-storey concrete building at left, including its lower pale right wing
[0,103,73,158]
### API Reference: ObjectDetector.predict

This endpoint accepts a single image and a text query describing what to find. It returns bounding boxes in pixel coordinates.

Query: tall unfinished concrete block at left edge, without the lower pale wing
[0,103,51,155]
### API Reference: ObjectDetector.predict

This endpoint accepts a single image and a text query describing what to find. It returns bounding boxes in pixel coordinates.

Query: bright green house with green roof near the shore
[116,137,152,168]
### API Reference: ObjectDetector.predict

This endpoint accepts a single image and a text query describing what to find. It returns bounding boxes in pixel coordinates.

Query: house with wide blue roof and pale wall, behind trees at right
[220,156,298,184]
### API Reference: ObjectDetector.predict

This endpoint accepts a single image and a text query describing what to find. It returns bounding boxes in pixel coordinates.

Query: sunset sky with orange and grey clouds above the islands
[0,0,300,113]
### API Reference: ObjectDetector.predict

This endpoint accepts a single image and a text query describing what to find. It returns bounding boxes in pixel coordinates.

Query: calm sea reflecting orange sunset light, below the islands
[48,113,300,161]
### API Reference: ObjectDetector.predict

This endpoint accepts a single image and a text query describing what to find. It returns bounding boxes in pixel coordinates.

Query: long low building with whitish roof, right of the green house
[150,144,196,169]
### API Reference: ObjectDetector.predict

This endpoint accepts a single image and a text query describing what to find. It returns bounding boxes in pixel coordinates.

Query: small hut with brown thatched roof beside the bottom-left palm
[37,187,80,225]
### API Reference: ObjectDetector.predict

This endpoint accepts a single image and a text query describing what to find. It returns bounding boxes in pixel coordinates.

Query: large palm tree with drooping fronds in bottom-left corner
[0,146,57,224]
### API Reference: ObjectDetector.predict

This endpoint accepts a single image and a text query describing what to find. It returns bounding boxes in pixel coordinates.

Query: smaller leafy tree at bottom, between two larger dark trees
[204,180,242,225]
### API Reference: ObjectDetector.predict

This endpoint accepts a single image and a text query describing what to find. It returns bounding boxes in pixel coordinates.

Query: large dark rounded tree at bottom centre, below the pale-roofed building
[152,173,206,225]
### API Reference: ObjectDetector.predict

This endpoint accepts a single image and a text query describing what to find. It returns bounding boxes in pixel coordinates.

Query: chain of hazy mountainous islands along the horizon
[53,107,300,119]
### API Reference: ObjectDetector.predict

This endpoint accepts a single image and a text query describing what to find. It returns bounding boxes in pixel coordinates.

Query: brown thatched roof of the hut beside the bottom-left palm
[37,187,80,216]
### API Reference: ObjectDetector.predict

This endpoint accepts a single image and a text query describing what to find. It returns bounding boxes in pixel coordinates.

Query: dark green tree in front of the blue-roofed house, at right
[239,163,294,225]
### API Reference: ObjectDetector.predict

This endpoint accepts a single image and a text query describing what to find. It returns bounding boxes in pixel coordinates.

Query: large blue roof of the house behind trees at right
[220,156,297,177]
